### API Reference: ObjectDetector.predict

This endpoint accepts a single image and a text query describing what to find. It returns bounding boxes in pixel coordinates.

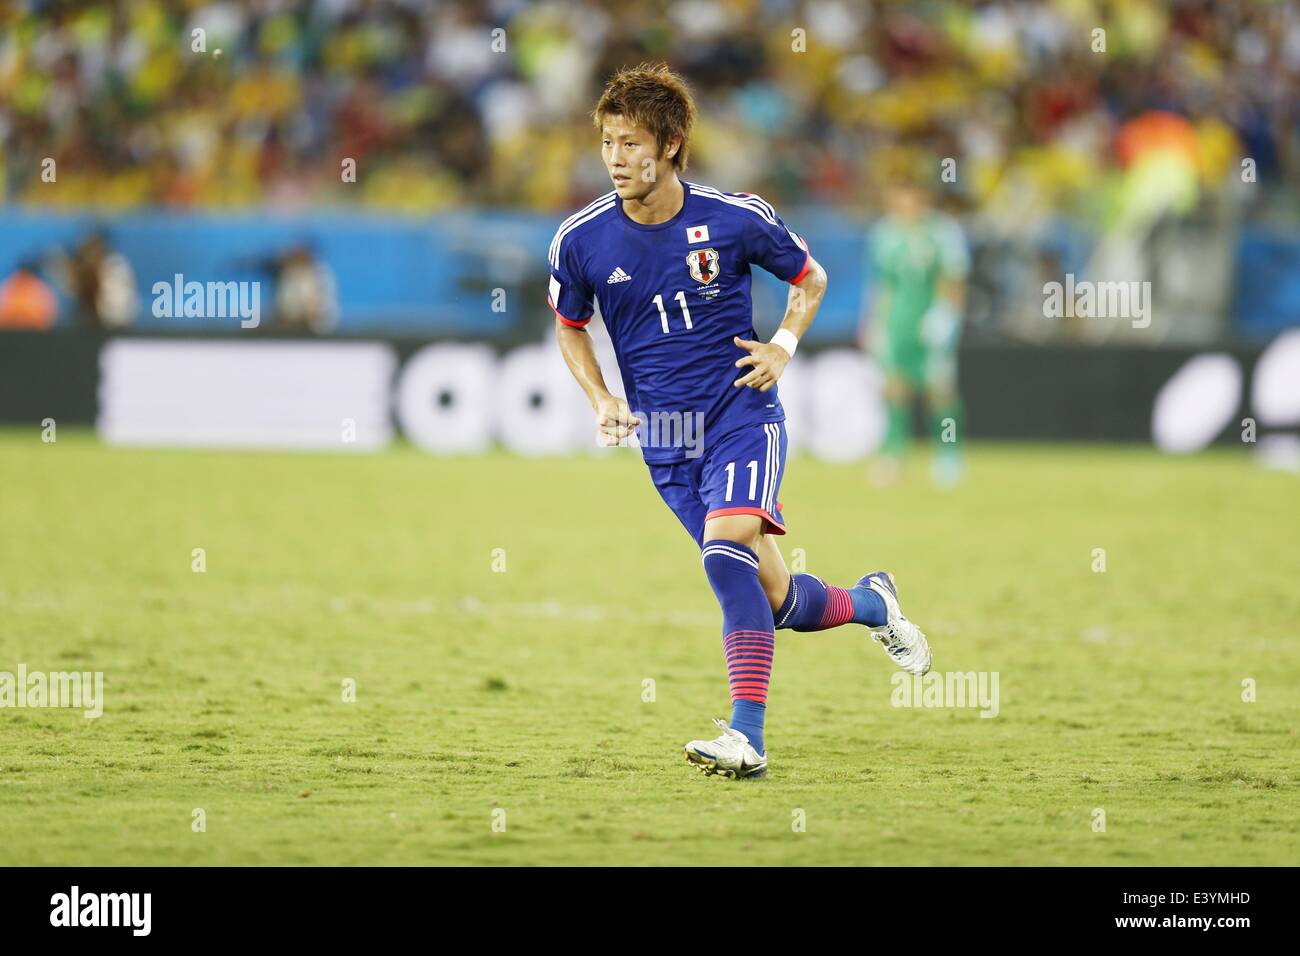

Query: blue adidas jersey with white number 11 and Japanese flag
[550,182,809,462]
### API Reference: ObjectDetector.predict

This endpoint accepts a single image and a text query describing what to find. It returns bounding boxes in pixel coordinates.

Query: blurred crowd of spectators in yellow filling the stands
[0,0,1300,225]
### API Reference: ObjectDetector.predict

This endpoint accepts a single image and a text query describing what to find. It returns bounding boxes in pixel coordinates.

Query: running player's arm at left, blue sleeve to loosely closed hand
[547,229,641,445]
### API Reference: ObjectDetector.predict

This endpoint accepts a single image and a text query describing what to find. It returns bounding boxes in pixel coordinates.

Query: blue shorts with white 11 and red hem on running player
[649,421,788,545]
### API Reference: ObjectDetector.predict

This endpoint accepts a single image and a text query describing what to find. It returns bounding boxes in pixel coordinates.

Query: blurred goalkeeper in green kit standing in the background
[861,170,970,485]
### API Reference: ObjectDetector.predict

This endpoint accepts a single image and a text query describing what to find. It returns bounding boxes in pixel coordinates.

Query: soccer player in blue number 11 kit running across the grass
[549,65,931,778]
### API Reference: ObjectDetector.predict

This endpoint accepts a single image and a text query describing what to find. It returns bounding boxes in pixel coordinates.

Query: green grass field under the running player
[0,428,1300,865]
